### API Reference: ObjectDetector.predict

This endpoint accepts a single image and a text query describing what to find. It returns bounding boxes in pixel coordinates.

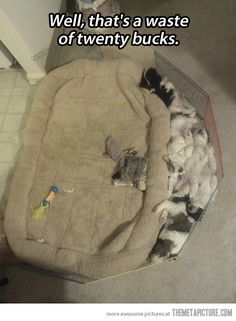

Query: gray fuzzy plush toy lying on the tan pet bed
[106,136,148,191]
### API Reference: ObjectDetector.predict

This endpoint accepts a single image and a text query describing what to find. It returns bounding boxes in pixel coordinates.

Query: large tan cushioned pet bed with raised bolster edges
[5,59,170,278]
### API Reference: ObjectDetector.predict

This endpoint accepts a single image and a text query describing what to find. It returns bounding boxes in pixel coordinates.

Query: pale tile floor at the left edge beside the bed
[0,67,32,216]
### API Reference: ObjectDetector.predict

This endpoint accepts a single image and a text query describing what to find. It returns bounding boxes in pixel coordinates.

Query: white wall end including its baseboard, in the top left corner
[0,0,62,83]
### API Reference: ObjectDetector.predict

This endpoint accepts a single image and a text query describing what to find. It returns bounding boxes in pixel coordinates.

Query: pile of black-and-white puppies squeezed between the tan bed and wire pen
[140,68,217,262]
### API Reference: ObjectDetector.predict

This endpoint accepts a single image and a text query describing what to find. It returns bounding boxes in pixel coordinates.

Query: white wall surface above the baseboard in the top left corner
[0,0,61,55]
